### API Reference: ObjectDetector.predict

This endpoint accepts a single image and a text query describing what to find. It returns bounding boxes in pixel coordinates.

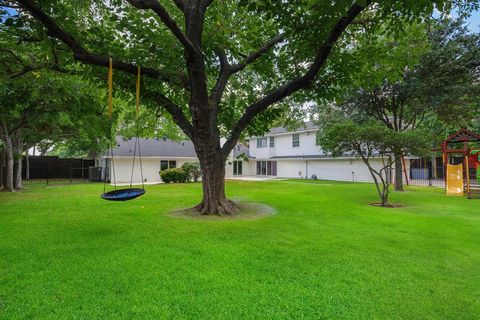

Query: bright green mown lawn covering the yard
[0,180,480,319]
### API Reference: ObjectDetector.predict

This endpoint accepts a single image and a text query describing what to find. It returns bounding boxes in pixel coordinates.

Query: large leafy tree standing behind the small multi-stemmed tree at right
[320,19,480,191]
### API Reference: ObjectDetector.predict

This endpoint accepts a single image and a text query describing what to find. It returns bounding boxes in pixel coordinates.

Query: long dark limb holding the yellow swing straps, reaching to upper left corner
[16,0,186,87]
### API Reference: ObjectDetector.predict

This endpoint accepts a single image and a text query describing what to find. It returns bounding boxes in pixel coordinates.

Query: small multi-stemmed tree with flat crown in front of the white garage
[319,120,428,207]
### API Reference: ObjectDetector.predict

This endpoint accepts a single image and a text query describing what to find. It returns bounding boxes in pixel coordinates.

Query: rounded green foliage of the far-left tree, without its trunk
[0,71,110,152]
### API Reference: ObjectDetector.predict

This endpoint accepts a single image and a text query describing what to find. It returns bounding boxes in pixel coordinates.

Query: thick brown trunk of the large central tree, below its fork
[195,150,238,215]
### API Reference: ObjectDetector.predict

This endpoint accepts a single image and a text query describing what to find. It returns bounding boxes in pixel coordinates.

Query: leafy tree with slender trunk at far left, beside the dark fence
[0,70,109,191]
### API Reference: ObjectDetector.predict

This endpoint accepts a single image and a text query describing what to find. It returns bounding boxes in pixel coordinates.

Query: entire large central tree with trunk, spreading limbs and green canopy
[2,0,477,214]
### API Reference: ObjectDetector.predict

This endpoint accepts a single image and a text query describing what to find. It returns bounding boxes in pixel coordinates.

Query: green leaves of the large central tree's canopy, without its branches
[4,0,479,142]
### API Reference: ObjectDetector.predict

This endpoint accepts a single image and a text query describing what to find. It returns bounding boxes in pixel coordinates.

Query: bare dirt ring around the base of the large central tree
[170,202,276,221]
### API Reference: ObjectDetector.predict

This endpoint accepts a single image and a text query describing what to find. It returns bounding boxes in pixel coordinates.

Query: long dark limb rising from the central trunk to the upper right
[222,0,371,154]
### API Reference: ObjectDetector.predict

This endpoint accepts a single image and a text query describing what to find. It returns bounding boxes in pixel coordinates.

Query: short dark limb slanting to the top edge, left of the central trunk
[127,0,200,54]
